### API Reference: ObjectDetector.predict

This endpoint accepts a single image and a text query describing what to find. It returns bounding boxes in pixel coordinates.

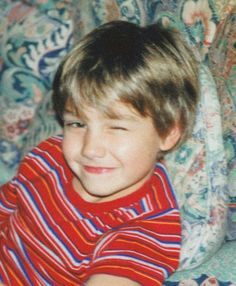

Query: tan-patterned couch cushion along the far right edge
[209,5,236,239]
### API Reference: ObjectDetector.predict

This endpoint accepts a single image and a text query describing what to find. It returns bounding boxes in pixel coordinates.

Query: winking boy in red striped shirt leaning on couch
[0,21,198,286]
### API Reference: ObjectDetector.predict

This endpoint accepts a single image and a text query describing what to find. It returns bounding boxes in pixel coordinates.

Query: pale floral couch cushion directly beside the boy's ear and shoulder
[166,64,228,270]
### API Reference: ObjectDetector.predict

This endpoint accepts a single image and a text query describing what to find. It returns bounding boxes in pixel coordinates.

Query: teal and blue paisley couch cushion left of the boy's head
[0,0,72,184]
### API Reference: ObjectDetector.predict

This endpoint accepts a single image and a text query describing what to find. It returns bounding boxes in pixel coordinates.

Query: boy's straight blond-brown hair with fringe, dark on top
[53,21,199,149]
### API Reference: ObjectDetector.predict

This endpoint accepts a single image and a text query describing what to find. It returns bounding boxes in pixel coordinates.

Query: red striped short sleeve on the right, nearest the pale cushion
[88,209,181,286]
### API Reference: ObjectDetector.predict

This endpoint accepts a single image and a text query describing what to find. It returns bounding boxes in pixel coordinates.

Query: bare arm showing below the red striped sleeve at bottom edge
[85,274,141,286]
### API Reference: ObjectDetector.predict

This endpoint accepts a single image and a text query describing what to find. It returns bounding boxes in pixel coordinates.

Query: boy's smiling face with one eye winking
[63,103,169,202]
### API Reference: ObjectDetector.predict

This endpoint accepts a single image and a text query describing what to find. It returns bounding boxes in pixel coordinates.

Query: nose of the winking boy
[82,131,106,159]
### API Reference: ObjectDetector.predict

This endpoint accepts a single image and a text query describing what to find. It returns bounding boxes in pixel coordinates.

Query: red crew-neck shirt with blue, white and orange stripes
[0,137,181,286]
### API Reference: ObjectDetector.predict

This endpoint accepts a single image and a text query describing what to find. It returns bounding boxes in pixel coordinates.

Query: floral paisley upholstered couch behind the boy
[0,0,236,286]
